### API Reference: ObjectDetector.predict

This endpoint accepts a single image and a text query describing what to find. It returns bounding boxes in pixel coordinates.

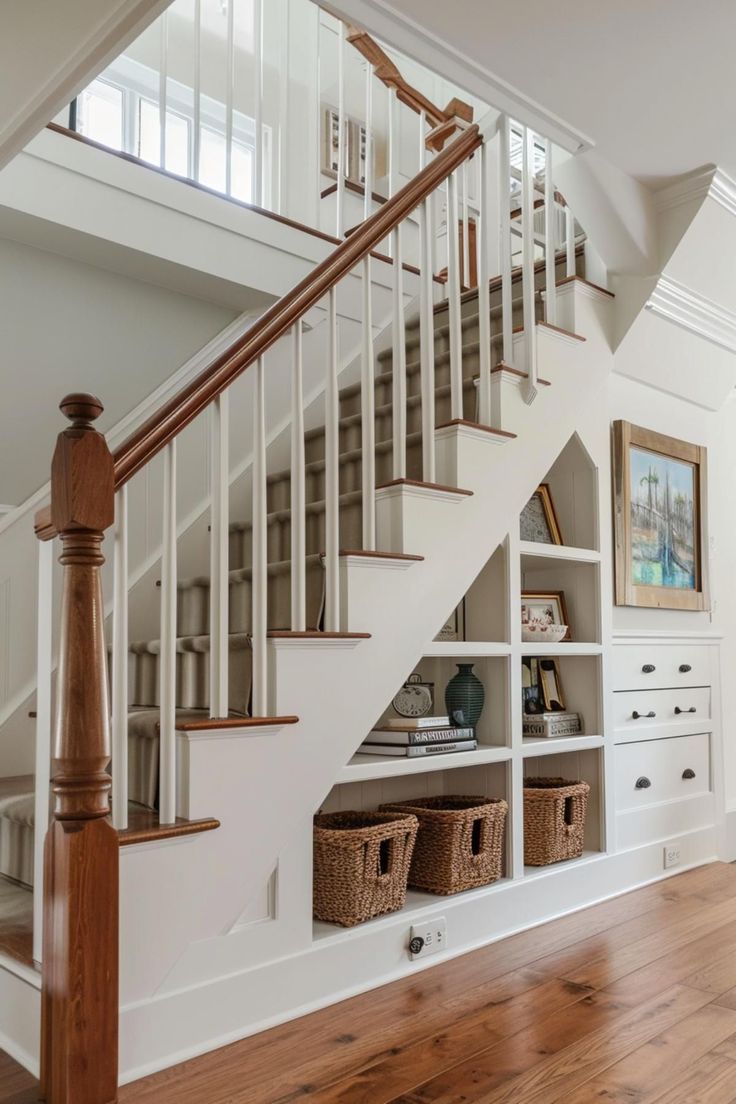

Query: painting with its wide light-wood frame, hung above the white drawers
[614,422,710,609]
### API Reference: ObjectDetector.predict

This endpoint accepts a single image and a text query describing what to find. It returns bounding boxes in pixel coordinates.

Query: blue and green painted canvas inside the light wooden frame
[629,446,696,591]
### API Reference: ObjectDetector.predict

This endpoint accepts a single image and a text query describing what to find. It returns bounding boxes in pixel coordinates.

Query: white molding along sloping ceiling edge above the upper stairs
[320,0,595,153]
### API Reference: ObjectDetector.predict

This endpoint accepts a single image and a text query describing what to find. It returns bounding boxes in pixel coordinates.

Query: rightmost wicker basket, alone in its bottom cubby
[524,778,590,867]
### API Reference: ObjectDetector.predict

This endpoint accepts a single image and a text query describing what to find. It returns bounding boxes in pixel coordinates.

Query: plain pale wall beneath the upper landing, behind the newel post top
[0,238,235,505]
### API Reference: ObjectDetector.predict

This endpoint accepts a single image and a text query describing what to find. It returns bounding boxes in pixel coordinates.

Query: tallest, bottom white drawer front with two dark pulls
[616,732,711,811]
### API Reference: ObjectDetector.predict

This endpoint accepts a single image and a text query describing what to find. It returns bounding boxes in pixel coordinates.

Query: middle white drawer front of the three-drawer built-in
[614,687,711,740]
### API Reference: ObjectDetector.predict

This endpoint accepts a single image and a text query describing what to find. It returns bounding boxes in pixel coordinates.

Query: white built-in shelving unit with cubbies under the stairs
[314,437,607,941]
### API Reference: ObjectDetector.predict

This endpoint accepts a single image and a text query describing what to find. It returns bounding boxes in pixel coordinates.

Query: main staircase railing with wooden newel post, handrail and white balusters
[35,38,575,1090]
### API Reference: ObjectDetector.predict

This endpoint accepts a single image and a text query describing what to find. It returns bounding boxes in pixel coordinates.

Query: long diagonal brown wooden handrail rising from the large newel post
[108,125,482,487]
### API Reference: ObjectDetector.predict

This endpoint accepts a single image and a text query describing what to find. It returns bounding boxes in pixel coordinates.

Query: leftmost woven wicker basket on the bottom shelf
[314,813,418,927]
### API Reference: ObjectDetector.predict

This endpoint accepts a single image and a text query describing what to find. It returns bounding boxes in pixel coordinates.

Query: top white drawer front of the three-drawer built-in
[612,644,711,690]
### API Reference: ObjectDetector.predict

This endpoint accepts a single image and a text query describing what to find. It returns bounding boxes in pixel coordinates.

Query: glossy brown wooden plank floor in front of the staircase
[7,863,736,1104]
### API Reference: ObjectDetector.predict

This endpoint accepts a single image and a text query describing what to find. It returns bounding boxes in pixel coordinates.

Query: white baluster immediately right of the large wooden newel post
[111,485,128,831]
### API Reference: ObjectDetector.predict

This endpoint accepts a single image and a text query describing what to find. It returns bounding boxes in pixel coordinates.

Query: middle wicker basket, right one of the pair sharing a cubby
[381,796,509,894]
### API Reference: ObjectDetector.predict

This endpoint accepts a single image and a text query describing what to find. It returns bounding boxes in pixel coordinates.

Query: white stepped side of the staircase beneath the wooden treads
[115,278,611,1076]
